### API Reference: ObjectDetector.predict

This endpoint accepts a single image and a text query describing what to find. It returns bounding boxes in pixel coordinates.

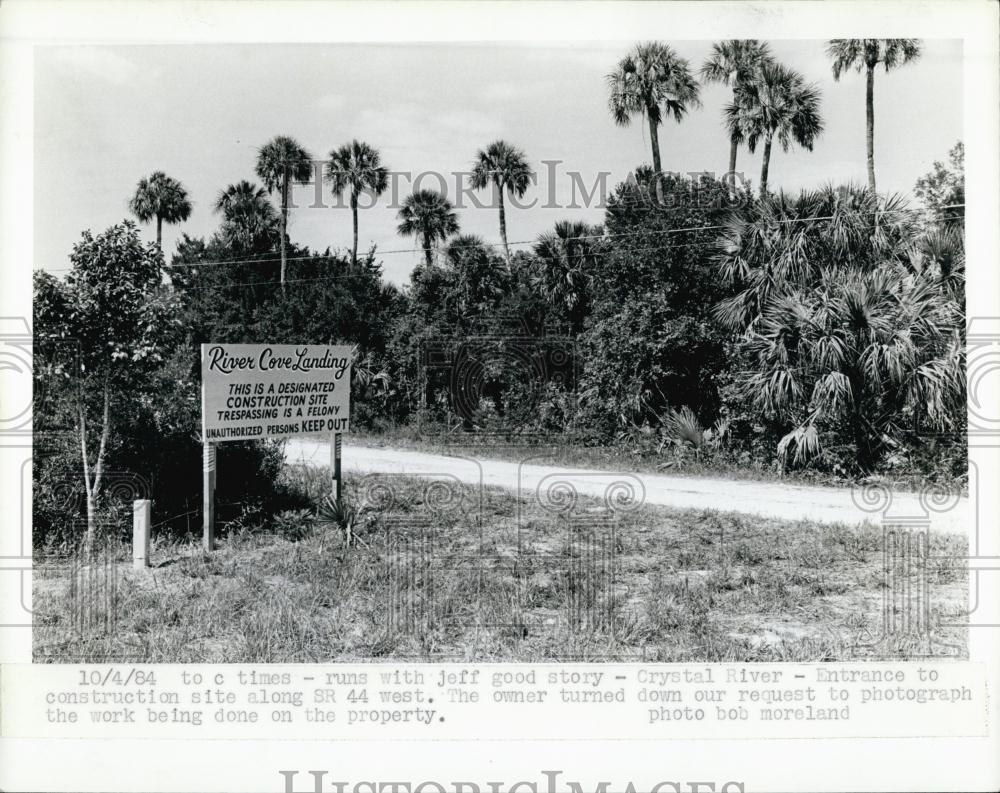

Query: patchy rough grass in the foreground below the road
[34,466,967,662]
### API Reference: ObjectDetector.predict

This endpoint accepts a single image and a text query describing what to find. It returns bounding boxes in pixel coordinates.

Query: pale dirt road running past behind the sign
[285,438,972,534]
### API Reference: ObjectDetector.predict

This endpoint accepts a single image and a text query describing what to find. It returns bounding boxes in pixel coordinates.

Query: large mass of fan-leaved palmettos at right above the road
[717,188,965,470]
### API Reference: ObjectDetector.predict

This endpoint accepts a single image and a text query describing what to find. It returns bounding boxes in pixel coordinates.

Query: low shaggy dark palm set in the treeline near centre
[533,220,604,333]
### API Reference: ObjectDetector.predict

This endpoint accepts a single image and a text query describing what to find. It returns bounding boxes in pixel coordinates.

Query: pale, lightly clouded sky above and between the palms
[34,40,962,283]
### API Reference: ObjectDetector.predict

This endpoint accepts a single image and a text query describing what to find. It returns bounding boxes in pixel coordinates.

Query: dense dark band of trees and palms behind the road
[34,40,966,547]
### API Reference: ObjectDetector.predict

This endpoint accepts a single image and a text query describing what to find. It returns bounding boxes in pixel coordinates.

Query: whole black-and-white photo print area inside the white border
[33,39,968,662]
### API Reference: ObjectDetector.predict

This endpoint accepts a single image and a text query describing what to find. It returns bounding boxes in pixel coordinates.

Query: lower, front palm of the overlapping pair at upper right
[726,61,823,195]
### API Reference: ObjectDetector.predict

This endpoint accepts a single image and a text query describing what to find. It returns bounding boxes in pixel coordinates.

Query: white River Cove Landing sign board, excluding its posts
[201,344,352,443]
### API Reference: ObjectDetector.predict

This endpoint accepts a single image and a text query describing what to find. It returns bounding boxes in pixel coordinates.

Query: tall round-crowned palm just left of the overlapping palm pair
[608,41,701,173]
